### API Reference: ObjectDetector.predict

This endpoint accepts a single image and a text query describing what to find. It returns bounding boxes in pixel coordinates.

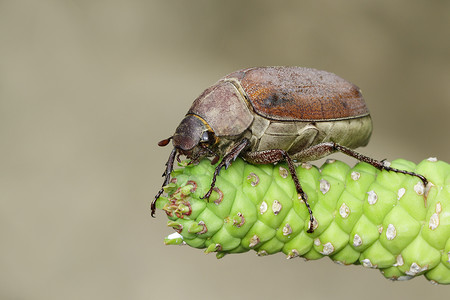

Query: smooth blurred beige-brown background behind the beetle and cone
[0,0,450,300]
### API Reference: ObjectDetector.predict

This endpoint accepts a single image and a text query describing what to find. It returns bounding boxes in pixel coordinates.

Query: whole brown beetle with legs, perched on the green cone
[151,67,428,232]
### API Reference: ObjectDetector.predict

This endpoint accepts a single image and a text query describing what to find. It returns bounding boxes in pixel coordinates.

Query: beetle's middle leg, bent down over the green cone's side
[244,149,315,233]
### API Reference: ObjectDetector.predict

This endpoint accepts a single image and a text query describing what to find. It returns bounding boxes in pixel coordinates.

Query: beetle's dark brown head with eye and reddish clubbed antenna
[158,115,217,160]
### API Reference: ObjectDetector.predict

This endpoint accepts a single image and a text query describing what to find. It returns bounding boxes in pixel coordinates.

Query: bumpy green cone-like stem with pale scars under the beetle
[157,158,450,284]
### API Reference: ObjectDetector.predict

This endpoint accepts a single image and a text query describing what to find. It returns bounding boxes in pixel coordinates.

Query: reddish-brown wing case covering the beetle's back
[225,67,369,121]
